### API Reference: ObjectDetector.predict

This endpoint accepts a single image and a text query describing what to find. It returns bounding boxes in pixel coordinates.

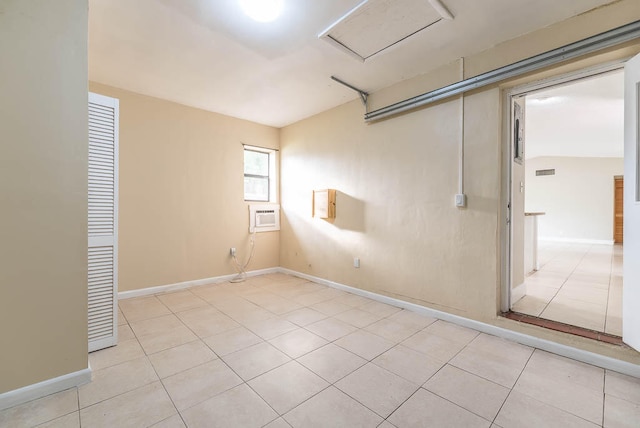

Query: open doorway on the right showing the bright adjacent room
[503,64,624,342]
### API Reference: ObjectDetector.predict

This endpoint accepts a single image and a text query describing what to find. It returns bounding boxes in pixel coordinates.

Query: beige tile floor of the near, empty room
[0,274,640,428]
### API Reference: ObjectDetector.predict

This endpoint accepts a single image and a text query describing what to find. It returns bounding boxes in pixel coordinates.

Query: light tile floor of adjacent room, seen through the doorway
[512,242,622,336]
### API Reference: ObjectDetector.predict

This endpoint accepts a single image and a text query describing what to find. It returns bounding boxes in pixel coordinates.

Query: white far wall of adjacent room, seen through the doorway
[525,157,624,242]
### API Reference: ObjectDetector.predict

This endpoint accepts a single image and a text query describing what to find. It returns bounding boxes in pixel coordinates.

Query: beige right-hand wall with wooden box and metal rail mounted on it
[280,0,640,363]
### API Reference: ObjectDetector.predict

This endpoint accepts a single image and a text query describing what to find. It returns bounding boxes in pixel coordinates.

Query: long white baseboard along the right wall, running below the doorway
[280,268,640,377]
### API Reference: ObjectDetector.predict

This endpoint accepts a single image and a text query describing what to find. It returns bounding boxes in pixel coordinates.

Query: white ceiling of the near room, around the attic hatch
[89,0,615,127]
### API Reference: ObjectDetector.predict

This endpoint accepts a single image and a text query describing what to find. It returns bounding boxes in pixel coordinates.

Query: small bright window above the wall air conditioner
[244,146,275,202]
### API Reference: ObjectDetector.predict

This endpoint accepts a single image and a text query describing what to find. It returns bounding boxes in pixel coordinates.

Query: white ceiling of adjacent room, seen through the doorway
[525,70,624,158]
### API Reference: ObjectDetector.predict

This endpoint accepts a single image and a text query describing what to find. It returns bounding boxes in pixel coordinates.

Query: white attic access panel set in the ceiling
[318,0,453,62]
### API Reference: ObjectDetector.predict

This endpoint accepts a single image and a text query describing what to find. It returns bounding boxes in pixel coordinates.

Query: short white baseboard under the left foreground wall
[0,368,91,410]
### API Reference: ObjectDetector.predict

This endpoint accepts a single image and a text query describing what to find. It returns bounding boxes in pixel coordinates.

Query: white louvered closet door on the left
[88,93,118,352]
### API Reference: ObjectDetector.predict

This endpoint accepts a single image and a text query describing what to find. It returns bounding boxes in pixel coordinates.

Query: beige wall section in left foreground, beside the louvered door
[0,0,87,393]
